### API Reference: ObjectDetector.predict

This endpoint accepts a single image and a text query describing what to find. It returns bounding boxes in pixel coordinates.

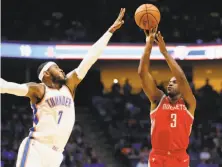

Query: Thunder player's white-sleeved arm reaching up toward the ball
[67,8,125,91]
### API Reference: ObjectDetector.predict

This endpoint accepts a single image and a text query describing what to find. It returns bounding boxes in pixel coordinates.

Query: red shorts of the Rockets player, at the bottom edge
[148,149,190,167]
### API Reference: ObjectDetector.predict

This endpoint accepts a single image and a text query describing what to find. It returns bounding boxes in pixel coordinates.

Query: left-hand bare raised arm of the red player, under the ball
[138,28,163,104]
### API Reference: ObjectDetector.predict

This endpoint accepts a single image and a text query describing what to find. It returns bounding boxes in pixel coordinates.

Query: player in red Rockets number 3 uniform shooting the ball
[138,28,196,167]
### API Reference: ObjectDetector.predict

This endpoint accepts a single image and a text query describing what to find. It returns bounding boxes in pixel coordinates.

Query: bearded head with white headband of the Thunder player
[37,61,66,84]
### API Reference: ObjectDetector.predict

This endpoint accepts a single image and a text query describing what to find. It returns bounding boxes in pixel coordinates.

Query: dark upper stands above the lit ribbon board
[1,0,222,43]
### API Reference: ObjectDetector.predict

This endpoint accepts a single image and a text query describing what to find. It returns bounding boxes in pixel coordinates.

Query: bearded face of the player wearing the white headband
[49,65,66,84]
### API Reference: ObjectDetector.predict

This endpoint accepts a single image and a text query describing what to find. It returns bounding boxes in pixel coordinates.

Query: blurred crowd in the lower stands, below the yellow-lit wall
[1,77,222,167]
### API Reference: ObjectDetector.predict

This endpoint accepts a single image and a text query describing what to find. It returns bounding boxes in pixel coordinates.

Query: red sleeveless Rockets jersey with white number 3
[150,95,194,151]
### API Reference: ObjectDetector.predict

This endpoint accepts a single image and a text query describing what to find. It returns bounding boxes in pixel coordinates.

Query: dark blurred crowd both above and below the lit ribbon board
[1,0,222,167]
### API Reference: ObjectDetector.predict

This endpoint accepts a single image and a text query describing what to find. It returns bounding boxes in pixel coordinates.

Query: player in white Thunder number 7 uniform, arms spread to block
[1,8,125,167]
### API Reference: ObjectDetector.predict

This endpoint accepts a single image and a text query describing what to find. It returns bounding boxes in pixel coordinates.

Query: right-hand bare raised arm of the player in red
[155,32,196,115]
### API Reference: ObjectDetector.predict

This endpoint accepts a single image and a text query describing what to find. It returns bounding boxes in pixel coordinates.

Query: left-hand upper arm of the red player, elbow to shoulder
[139,72,164,104]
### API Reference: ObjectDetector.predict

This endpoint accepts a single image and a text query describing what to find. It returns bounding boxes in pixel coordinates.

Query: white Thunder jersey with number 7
[30,85,75,151]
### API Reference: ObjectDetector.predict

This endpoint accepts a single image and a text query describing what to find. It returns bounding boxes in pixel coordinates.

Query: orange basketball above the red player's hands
[134,4,160,30]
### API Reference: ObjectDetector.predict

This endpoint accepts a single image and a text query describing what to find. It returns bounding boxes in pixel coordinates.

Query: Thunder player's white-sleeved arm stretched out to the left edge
[0,78,44,103]
